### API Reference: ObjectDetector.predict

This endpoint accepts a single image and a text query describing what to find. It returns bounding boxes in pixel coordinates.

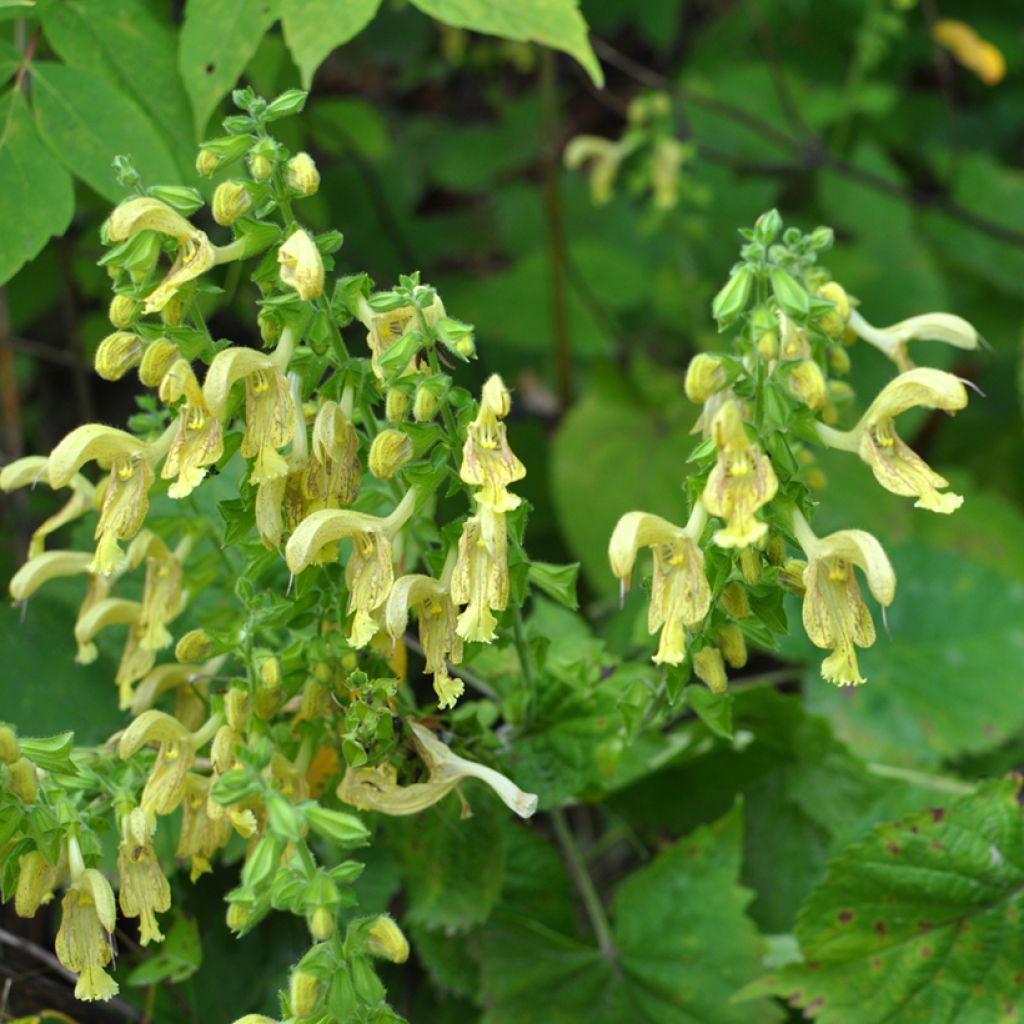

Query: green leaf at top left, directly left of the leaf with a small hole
[42,0,195,154]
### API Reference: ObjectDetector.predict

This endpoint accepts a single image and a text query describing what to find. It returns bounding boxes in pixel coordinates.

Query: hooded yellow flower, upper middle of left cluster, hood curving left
[203,330,298,483]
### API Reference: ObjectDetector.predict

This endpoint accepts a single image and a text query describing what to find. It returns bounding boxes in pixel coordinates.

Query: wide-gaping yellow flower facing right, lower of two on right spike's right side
[817,368,967,514]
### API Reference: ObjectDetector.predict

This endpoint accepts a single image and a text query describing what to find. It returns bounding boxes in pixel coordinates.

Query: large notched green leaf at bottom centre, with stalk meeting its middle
[475,810,779,1024]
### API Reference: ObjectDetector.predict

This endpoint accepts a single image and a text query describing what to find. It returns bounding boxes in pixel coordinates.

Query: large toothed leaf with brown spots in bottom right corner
[746,778,1024,1024]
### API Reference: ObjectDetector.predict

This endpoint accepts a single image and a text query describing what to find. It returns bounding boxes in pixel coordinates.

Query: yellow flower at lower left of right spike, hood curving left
[608,502,711,665]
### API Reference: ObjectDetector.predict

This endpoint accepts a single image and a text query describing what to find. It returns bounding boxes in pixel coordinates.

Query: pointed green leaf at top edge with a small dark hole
[178,0,279,135]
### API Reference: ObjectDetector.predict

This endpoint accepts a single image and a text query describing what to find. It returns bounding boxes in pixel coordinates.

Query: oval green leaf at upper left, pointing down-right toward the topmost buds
[32,61,180,202]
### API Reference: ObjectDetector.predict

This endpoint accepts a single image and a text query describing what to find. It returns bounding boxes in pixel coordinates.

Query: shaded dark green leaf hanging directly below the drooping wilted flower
[388,791,505,931]
